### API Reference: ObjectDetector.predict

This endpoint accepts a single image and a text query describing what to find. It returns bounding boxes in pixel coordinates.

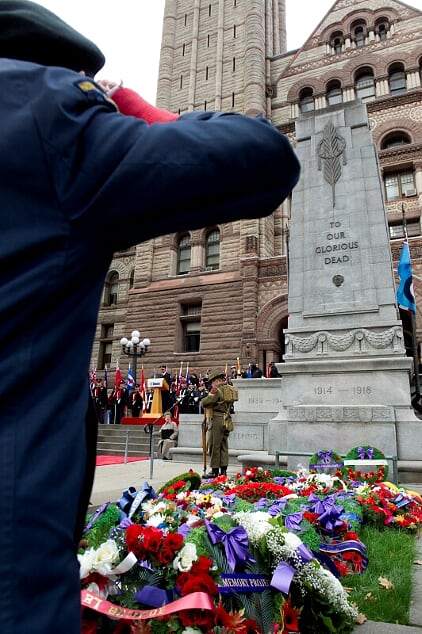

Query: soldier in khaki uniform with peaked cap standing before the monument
[201,370,230,478]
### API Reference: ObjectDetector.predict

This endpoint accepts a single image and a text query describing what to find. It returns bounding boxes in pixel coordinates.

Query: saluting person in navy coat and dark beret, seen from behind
[0,0,300,634]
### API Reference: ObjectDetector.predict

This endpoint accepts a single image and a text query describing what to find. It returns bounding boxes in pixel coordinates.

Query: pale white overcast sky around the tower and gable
[36,0,422,103]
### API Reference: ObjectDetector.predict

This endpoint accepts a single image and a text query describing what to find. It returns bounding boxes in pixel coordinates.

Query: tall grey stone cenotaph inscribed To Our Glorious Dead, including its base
[268,102,422,468]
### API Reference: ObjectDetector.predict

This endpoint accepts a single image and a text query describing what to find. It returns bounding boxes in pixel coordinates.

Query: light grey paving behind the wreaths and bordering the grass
[91,459,422,634]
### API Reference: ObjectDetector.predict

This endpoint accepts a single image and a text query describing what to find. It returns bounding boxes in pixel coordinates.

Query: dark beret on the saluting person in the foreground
[0,0,105,77]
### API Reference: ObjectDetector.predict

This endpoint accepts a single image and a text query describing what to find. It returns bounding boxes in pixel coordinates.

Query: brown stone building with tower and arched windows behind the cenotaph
[92,0,422,376]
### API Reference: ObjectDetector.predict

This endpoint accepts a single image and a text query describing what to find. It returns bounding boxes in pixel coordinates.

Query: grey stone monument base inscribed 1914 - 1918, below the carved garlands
[268,357,422,469]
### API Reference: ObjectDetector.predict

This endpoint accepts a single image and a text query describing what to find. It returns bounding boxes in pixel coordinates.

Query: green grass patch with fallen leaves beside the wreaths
[341,525,416,625]
